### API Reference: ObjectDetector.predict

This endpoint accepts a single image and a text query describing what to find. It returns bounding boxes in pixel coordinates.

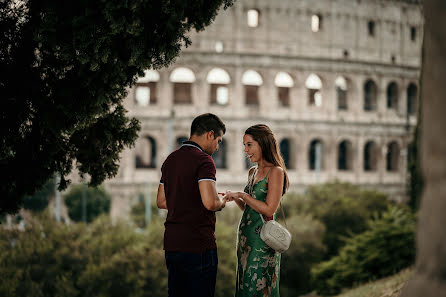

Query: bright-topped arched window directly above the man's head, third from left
[206,68,231,105]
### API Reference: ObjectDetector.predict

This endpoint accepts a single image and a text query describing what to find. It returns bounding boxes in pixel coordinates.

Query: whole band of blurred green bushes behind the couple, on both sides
[0,182,415,297]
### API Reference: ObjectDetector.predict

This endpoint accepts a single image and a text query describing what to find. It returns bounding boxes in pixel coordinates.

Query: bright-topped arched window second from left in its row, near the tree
[170,67,195,104]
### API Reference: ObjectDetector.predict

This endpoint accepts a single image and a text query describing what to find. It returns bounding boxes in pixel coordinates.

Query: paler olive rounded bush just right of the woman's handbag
[285,182,390,259]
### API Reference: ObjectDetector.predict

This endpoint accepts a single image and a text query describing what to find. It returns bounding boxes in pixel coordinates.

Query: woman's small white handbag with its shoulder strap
[249,168,291,253]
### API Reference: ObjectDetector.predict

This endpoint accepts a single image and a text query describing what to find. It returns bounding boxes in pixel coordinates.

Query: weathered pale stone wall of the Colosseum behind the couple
[106,0,423,216]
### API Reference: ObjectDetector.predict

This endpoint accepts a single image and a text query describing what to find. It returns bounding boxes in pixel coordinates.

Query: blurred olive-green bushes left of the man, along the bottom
[0,212,167,297]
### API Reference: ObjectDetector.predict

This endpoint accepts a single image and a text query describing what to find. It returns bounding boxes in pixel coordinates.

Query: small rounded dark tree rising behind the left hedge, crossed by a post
[64,184,111,223]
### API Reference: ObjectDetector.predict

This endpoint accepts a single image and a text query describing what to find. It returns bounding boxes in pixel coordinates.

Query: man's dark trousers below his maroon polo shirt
[165,249,218,297]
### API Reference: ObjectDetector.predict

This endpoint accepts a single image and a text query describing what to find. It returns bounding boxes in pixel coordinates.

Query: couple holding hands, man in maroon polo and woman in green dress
[157,113,289,297]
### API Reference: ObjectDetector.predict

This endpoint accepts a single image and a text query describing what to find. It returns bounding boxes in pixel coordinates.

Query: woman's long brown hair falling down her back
[245,124,290,195]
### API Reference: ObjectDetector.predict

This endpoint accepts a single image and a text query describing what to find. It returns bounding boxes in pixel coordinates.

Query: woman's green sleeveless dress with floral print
[235,168,281,297]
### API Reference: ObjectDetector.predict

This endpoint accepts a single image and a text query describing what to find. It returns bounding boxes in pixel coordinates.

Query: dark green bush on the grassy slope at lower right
[313,207,415,295]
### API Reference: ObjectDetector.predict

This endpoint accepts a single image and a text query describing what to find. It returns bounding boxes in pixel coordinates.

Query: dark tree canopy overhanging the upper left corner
[0,0,233,213]
